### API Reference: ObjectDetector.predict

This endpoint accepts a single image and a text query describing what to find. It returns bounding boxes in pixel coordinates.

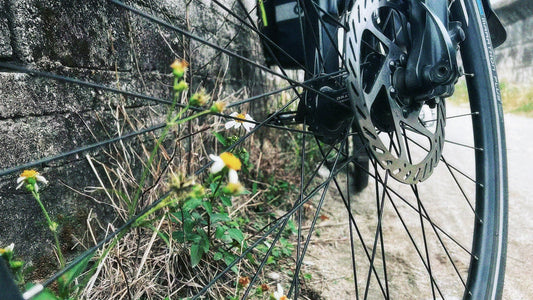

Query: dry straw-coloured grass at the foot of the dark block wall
[70,83,312,299]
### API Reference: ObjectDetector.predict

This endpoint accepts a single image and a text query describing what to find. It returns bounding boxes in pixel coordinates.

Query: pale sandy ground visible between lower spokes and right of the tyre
[303,108,533,300]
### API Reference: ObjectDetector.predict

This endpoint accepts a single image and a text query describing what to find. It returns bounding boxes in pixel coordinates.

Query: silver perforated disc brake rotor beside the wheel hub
[346,0,445,184]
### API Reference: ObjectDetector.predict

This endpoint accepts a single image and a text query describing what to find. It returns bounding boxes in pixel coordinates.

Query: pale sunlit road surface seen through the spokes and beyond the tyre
[309,105,533,300]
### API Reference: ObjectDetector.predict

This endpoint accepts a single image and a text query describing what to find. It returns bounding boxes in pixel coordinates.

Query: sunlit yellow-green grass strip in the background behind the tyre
[450,79,533,117]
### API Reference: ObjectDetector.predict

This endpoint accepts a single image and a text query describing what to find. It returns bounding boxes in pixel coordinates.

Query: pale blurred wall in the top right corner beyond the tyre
[494,0,533,84]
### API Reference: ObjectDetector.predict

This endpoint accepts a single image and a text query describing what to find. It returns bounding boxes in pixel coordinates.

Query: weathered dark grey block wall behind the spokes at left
[0,0,262,266]
